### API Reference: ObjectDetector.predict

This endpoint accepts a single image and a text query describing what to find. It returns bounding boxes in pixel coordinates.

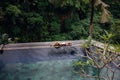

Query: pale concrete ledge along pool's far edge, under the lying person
[4,40,83,50]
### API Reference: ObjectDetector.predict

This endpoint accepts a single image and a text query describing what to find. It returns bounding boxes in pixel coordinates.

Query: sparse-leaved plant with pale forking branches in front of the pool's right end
[75,32,120,80]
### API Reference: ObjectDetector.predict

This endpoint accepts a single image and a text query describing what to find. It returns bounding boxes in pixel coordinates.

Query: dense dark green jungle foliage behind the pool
[0,0,120,42]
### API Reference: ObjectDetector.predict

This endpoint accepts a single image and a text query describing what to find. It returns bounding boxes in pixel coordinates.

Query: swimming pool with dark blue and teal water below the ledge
[0,43,120,80]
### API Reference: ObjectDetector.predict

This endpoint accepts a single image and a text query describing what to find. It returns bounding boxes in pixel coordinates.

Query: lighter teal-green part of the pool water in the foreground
[0,60,119,80]
